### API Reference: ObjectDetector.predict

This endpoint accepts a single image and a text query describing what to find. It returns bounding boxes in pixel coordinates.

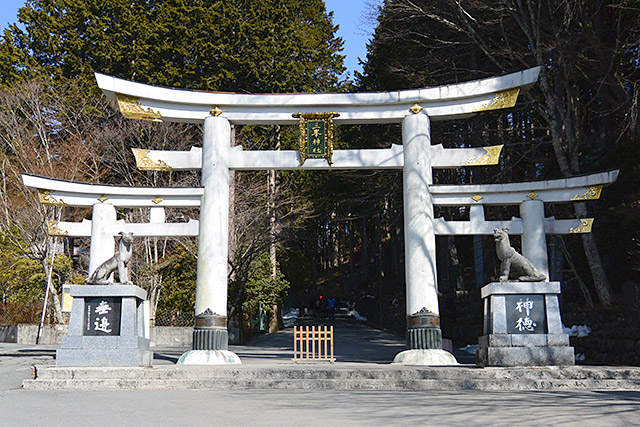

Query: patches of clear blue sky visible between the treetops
[0,0,377,76]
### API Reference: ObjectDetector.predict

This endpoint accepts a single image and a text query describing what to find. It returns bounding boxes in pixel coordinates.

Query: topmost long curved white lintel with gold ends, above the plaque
[95,67,540,124]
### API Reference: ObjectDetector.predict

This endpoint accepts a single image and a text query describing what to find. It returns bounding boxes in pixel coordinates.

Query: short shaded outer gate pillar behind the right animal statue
[520,200,549,280]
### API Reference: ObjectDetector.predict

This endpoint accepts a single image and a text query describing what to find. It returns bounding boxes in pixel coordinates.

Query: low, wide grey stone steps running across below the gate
[23,364,640,390]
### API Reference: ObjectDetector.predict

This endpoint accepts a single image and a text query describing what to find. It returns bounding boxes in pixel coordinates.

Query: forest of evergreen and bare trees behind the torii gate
[0,0,640,352]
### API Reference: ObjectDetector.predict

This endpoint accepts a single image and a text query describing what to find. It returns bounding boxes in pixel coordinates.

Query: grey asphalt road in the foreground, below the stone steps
[0,389,640,427]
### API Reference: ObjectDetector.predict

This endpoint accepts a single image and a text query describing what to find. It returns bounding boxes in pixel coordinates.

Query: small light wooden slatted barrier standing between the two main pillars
[291,326,336,363]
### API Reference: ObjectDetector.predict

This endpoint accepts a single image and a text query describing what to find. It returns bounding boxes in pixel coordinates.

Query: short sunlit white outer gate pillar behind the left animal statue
[89,203,116,281]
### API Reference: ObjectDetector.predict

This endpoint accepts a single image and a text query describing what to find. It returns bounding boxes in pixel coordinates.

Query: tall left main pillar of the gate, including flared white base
[178,116,241,365]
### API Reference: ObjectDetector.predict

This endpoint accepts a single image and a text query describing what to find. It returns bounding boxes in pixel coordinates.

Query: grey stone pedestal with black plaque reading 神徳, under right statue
[476,282,575,366]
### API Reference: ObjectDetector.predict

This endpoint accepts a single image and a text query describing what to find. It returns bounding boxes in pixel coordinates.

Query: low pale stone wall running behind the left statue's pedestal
[0,324,193,347]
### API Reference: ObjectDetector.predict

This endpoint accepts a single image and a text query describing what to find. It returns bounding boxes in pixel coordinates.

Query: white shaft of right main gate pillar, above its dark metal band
[402,114,439,315]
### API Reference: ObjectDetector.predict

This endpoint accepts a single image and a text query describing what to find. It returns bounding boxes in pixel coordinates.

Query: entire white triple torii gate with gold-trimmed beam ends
[18,64,617,364]
